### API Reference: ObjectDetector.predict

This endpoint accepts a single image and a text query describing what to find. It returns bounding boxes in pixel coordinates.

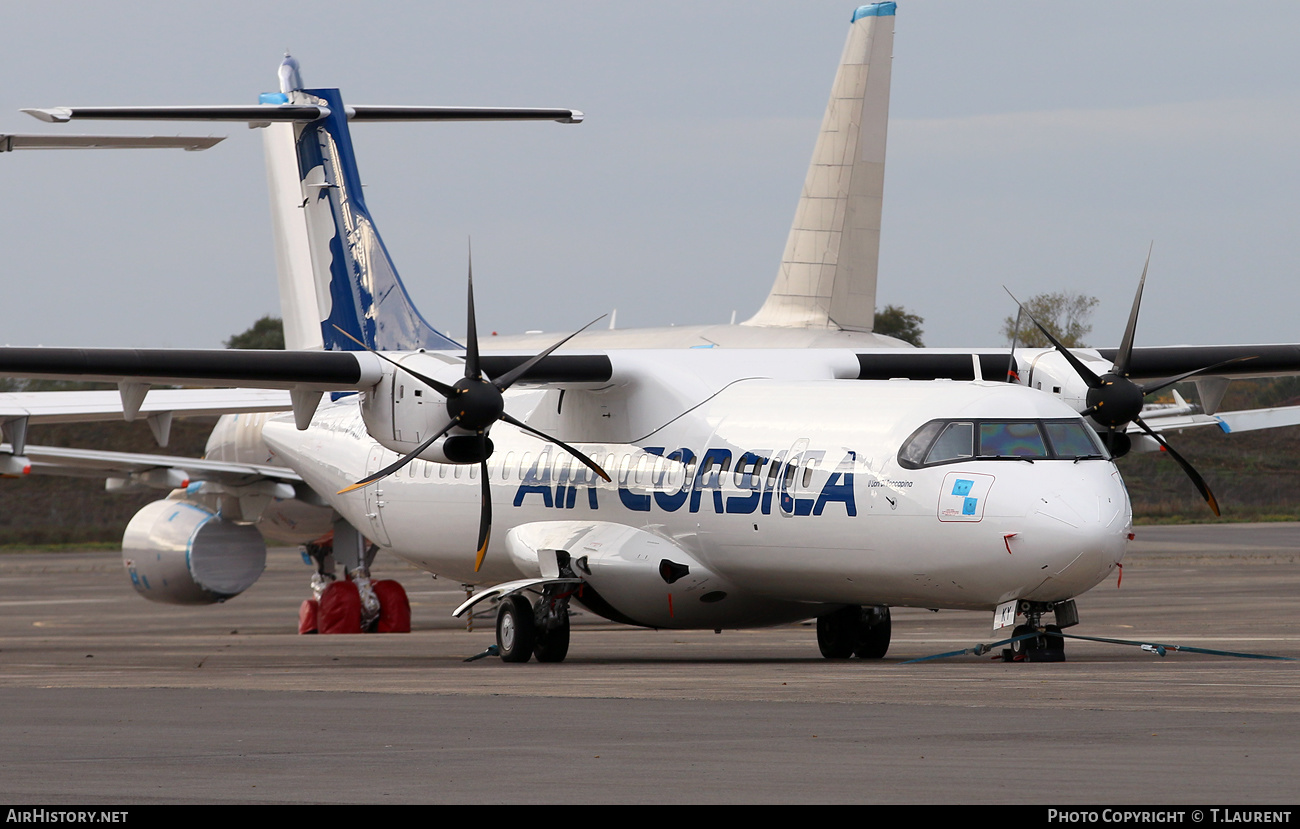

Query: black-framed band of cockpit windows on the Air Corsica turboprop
[898,418,1109,469]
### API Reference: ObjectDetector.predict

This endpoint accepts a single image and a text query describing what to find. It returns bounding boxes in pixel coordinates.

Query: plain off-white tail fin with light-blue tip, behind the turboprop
[745,3,894,331]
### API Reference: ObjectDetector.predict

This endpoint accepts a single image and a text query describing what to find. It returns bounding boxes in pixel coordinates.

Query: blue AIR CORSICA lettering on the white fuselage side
[514,447,868,517]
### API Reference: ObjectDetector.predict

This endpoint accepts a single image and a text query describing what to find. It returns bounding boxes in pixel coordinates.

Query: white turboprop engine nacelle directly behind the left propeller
[361,352,481,464]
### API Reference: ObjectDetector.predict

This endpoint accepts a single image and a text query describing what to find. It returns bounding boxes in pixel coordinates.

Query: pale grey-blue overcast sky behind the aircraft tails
[0,0,1300,347]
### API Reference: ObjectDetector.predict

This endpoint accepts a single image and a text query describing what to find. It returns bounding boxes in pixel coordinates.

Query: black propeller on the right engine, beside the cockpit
[1008,248,1255,516]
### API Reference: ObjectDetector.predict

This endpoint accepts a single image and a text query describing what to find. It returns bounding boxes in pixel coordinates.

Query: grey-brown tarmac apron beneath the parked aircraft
[0,524,1300,808]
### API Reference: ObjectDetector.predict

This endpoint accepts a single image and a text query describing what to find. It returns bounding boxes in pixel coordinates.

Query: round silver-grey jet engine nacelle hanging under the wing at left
[122,500,267,604]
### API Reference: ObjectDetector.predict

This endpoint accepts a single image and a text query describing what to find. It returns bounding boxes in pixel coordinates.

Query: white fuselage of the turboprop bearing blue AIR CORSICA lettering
[264,379,1131,626]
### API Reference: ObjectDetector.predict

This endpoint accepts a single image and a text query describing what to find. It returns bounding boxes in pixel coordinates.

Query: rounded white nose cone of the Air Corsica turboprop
[1021,461,1132,602]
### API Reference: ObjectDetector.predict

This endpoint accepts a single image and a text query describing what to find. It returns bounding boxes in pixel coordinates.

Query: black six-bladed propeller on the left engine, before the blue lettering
[334,253,610,573]
